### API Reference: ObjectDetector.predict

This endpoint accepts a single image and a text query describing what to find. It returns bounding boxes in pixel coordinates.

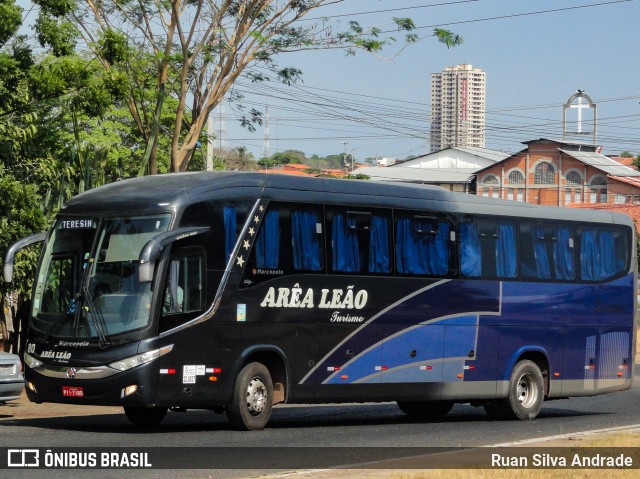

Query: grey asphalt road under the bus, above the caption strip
[0,387,640,448]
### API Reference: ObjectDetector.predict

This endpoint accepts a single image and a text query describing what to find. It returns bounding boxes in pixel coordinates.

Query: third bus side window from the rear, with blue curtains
[460,219,518,278]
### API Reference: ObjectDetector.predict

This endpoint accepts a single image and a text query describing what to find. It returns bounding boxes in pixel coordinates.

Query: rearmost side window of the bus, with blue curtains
[580,227,629,281]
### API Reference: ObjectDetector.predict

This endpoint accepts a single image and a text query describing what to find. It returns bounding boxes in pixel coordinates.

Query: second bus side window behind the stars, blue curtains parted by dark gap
[327,210,391,274]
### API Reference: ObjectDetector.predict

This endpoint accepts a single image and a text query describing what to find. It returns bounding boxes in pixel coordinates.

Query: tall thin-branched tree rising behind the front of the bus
[34,0,462,173]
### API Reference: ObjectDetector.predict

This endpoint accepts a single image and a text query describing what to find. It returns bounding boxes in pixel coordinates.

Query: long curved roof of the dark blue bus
[61,172,633,227]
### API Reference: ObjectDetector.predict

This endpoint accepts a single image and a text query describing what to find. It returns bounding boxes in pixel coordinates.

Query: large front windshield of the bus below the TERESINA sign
[31,214,171,338]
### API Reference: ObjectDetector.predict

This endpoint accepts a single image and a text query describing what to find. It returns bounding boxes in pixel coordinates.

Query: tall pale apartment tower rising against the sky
[430,64,486,151]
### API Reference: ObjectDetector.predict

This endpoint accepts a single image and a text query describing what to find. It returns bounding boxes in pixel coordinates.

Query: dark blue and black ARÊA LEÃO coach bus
[4,172,637,430]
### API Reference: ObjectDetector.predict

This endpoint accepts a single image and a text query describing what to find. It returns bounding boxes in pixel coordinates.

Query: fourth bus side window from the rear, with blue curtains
[396,213,453,276]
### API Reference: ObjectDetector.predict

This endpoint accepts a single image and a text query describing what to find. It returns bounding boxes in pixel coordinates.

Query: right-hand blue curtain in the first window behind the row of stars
[291,211,322,271]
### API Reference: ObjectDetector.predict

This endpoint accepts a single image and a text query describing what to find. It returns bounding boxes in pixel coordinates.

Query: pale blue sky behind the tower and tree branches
[219,0,640,161]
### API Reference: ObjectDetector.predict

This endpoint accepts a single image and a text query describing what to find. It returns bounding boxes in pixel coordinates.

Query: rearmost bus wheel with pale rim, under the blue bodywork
[496,360,544,420]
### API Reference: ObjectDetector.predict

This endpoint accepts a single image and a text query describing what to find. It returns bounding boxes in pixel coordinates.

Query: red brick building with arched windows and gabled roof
[476,138,640,206]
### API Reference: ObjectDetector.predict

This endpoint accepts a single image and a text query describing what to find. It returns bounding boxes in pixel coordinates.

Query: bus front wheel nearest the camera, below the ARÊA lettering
[227,362,273,431]
